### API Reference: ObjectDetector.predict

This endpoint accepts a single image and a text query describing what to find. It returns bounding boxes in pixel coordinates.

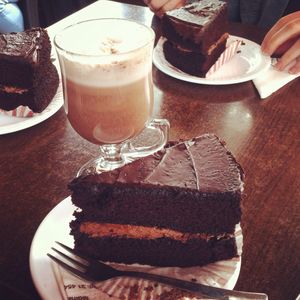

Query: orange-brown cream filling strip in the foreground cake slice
[79,222,234,243]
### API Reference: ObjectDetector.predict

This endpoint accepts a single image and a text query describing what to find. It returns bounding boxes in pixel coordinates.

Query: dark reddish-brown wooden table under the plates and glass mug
[0,1,300,300]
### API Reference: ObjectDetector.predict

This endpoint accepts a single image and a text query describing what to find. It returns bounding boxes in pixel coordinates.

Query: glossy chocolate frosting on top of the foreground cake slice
[77,134,243,192]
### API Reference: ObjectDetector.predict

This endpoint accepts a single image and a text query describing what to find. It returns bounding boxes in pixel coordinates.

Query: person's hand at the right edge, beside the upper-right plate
[261,11,300,74]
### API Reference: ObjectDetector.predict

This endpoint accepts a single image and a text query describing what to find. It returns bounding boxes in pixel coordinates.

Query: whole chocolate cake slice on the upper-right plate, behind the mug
[162,0,228,76]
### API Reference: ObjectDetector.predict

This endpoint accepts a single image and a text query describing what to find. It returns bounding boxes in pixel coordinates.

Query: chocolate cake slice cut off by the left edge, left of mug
[0,28,59,112]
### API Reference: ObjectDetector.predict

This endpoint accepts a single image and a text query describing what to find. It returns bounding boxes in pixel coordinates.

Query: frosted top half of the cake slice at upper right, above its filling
[162,0,229,54]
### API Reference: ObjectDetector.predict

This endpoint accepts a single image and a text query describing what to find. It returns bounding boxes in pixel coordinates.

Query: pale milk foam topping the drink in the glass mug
[55,19,154,87]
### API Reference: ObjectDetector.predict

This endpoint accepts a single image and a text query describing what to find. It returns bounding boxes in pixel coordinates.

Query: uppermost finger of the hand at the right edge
[261,11,300,55]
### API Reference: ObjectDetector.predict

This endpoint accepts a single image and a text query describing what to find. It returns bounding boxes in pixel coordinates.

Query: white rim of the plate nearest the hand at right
[153,35,271,85]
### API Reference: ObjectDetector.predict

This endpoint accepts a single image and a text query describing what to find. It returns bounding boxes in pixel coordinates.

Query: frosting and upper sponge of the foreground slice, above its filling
[69,134,243,234]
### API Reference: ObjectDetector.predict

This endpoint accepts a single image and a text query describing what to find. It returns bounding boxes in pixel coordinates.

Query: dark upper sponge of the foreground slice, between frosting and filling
[73,188,241,234]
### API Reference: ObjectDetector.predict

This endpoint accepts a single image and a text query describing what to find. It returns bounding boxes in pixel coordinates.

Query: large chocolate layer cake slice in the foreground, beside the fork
[69,134,243,266]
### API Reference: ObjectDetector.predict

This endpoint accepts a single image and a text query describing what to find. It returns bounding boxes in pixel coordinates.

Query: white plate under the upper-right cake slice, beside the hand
[153,36,271,85]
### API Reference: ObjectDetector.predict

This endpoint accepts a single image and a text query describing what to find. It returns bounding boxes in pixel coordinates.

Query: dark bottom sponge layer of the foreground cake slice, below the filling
[73,224,237,267]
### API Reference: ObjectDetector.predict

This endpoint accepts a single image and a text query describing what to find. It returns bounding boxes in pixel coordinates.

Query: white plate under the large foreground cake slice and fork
[29,197,242,300]
